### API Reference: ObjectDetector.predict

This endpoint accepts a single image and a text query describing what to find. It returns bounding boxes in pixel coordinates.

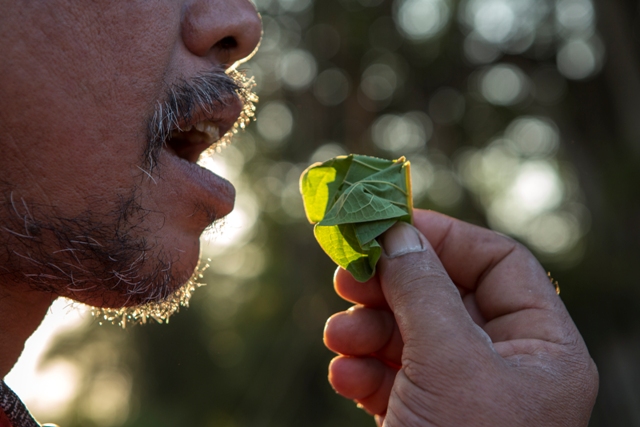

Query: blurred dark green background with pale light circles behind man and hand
[7,0,640,427]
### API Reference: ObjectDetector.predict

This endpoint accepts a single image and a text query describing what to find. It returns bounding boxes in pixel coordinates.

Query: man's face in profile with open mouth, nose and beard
[0,0,261,307]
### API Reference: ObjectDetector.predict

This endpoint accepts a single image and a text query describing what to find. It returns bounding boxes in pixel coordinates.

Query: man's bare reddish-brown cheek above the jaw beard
[0,1,180,213]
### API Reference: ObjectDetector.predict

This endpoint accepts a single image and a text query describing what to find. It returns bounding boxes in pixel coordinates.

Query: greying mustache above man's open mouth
[144,69,241,171]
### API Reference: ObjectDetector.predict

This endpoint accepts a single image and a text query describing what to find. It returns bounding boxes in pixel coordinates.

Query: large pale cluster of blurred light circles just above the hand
[457,120,589,254]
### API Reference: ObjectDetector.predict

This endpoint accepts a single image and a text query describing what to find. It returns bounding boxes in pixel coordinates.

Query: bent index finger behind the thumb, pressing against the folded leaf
[414,209,564,338]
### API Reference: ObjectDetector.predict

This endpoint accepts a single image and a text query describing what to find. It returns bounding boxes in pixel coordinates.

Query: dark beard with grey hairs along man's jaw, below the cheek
[0,189,187,305]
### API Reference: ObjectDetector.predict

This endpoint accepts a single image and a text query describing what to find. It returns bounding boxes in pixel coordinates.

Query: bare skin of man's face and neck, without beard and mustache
[0,0,261,376]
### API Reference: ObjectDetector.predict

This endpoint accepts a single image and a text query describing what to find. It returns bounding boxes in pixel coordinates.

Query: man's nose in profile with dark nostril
[182,0,262,68]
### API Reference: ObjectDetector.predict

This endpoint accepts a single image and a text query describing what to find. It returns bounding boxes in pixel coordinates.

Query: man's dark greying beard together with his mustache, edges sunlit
[0,71,257,327]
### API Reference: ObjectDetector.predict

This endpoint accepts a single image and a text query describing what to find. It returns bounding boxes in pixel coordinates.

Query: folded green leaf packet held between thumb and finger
[300,154,412,282]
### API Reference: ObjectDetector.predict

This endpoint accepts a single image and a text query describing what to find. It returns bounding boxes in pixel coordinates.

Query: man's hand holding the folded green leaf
[325,210,598,427]
